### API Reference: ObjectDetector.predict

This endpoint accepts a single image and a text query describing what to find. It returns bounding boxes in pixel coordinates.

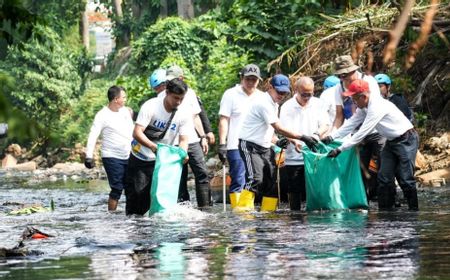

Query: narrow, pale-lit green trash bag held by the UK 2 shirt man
[149,144,187,215]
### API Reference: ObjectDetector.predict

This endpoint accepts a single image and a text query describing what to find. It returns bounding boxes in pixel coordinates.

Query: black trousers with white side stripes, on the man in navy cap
[239,140,278,197]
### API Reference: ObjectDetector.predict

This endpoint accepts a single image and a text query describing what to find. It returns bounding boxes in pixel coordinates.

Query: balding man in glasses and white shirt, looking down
[280,77,331,210]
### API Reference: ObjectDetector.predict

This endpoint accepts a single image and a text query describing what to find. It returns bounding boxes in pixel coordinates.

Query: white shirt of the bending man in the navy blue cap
[239,92,279,148]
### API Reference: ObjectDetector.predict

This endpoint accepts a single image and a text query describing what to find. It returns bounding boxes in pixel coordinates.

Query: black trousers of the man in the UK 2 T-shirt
[125,154,155,215]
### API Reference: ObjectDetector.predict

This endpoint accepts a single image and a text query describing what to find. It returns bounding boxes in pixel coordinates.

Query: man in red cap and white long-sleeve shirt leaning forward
[323,80,419,210]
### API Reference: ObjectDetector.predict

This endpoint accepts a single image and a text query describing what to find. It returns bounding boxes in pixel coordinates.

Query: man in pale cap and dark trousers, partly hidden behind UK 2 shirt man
[164,65,212,207]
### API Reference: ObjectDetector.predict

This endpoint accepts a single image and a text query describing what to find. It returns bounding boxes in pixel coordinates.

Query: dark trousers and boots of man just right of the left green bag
[178,143,211,207]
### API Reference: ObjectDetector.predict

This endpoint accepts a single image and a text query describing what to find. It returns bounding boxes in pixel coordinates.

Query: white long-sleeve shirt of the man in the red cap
[331,95,413,151]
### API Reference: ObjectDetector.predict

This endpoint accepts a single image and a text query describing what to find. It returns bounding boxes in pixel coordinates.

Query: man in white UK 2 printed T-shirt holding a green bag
[125,79,192,215]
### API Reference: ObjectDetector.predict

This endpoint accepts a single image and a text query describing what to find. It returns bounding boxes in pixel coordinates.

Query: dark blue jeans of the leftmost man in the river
[102,158,128,200]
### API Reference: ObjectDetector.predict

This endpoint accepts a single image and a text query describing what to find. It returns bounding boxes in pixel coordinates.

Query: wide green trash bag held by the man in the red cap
[302,141,368,211]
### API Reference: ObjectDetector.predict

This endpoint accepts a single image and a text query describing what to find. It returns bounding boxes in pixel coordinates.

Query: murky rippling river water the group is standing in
[0,174,450,279]
